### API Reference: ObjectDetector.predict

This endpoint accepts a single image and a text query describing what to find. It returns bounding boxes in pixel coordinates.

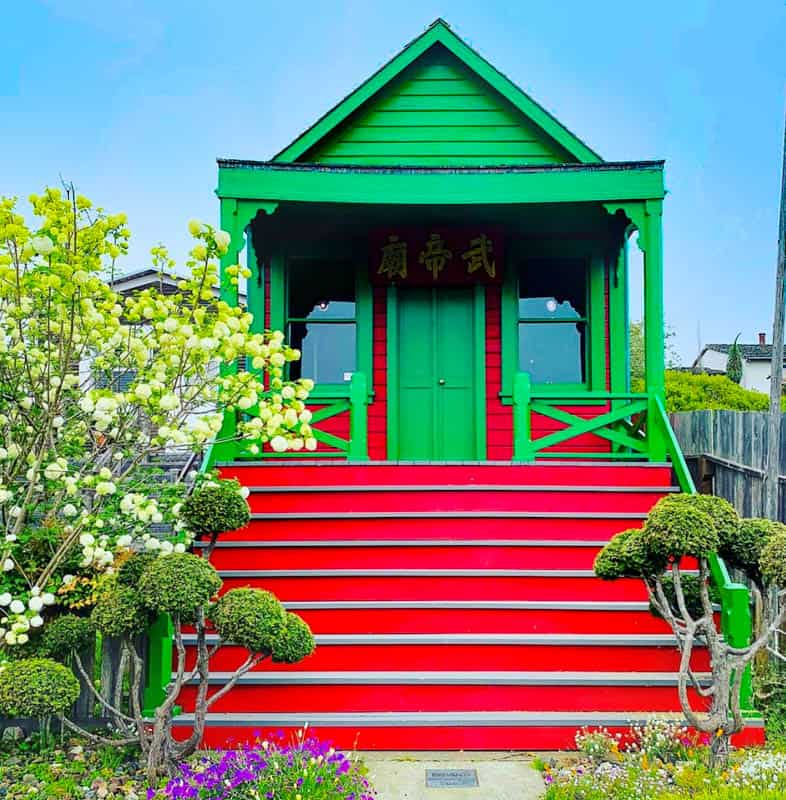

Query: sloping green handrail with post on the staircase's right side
[655,397,753,710]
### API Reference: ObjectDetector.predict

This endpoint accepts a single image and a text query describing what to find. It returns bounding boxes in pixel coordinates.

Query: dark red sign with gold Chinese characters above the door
[371,228,504,286]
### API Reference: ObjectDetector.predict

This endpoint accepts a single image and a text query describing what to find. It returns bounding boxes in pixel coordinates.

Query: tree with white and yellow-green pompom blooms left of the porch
[0,189,316,647]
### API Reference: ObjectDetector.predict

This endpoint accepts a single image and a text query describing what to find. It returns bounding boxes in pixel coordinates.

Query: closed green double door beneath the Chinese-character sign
[397,288,478,461]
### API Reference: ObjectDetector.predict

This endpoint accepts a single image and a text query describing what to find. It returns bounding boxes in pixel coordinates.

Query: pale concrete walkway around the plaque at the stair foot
[359,751,544,800]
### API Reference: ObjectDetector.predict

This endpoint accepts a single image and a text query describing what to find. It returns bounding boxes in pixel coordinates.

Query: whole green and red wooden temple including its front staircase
[165,20,747,749]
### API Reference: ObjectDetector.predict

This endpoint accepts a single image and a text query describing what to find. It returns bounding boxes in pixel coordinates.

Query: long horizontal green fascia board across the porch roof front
[217,159,665,205]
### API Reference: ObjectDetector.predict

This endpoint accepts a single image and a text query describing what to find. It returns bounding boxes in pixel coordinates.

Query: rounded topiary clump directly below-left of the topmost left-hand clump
[139,553,221,617]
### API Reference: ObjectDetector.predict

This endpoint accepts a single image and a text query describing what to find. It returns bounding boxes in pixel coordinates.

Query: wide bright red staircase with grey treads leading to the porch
[173,462,760,750]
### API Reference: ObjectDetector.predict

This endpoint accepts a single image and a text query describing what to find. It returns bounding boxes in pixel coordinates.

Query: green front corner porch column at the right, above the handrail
[639,200,666,461]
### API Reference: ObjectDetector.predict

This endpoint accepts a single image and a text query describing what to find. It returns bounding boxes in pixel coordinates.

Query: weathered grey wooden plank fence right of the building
[670,411,786,521]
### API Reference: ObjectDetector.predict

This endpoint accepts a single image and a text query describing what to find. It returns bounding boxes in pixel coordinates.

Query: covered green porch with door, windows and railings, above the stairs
[213,161,668,461]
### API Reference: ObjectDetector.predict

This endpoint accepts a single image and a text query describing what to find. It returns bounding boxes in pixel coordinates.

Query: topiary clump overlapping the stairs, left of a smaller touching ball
[211,589,287,653]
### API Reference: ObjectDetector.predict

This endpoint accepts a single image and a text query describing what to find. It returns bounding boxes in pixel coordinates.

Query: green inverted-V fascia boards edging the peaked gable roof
[273,19,603,163]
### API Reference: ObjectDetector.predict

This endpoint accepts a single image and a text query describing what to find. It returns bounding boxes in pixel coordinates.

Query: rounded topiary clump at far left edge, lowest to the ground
[0,658,79,719]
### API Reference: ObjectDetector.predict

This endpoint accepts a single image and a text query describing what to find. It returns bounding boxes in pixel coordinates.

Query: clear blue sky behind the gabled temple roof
[0,0,786,361]
